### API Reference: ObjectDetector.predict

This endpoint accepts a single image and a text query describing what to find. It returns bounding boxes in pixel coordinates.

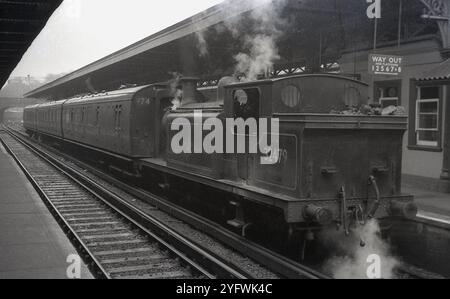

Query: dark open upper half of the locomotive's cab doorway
[233,88,260,119]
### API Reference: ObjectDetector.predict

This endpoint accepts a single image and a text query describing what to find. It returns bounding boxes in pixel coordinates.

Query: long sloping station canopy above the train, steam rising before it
[26,0,439,100]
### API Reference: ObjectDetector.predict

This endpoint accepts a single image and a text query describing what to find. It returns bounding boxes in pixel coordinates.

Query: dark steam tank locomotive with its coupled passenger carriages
[24,74,417,237]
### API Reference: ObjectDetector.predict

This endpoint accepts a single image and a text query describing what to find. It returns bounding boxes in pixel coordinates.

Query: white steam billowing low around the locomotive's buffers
[320,220,400,279]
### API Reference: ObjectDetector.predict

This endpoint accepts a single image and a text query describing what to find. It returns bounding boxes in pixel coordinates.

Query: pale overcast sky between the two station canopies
[12,0,223,78]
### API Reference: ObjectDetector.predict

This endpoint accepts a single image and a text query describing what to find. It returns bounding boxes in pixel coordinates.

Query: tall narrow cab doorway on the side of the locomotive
[233,88,260,181]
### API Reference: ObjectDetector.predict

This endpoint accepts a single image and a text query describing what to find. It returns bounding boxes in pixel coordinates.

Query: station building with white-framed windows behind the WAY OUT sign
[339,4,450,193]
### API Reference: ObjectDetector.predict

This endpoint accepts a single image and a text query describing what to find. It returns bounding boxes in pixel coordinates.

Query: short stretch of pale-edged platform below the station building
[403,185,450,223]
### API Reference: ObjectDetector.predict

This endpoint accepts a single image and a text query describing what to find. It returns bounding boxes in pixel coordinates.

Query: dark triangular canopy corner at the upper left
[0,0,62,86]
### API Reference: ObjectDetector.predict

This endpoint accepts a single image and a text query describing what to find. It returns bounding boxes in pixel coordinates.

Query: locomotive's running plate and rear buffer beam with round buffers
[141,159,417,229]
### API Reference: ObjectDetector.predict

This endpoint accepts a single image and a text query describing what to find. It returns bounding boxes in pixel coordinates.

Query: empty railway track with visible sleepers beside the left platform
[0,131,255,279]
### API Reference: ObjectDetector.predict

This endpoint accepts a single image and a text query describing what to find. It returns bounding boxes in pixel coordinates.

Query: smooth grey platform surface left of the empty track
[0,140,93,279]
